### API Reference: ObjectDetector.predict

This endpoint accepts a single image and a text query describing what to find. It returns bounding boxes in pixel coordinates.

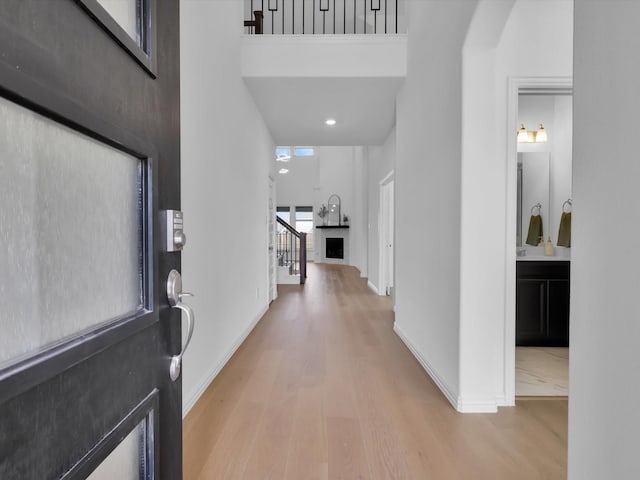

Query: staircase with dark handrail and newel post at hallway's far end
[276,216,307,285]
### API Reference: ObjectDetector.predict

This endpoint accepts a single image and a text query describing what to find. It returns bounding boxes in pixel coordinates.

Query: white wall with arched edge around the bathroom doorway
[460,0,573,411]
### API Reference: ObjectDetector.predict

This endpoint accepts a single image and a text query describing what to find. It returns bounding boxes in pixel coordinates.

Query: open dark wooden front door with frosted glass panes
[0,0,182,480]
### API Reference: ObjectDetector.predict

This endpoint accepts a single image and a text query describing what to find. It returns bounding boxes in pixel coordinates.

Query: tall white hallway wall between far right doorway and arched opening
[394,0,476,408]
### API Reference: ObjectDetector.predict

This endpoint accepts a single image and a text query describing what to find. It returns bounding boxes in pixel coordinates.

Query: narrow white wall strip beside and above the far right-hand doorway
[366,128,396,294]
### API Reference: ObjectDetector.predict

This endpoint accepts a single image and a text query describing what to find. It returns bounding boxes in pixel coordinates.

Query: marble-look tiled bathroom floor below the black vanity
[516,347,569,397]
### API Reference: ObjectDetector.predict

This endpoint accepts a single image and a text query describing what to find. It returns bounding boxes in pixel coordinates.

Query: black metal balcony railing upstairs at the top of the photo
[244,0,399,35]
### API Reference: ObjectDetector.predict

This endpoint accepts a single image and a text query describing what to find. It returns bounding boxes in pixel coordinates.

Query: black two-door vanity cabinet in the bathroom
[516,261,569,347]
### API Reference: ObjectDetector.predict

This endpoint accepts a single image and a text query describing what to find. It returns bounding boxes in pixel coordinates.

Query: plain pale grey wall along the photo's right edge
[568,0,640,480]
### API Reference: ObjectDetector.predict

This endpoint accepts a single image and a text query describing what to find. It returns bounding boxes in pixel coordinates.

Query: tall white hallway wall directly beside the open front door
[179,0,274,414]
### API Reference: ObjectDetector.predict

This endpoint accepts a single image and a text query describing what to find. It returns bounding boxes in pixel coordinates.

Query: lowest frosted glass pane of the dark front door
[87,420,149,480]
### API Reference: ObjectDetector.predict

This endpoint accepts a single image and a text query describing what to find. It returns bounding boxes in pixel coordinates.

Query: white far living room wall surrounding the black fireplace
[276,146,367,275]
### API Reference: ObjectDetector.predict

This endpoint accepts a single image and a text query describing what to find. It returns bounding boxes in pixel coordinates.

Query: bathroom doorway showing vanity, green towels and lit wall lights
[505,78,573,397]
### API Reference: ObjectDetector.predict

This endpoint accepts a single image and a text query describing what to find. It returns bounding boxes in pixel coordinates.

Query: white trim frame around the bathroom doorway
[503,76,573,406]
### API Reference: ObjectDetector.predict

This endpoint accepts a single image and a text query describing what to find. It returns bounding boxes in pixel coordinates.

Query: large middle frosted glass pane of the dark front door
[0,97,143,365]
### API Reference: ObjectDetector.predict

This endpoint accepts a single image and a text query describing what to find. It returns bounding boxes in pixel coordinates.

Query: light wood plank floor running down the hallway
[184,264,567,480]
